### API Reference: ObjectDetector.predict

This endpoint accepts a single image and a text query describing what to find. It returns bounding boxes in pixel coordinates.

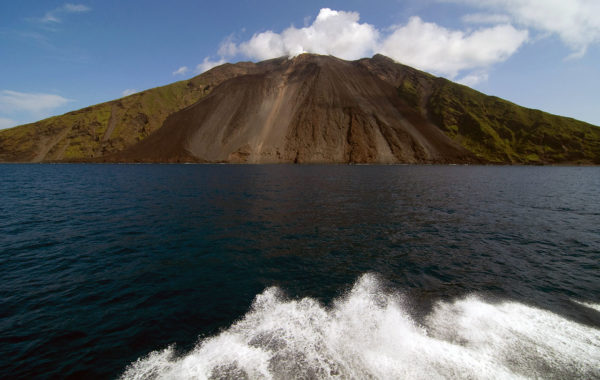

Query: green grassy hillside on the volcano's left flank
[0,71,222,162]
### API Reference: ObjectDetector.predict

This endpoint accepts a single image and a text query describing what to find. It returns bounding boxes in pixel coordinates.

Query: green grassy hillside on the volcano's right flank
[398,71,600,164]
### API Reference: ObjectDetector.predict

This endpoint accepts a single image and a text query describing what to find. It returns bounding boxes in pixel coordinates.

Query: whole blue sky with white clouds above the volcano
[0,0,600,129]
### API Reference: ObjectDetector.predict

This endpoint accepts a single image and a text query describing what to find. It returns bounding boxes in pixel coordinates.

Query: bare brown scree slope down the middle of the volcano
[106,54,479,163]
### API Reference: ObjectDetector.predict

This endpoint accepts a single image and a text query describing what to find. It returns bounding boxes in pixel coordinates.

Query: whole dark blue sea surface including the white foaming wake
[0,164,600,379]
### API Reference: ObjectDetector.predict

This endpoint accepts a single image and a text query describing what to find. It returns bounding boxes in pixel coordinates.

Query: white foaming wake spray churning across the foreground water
[122,274,600,379]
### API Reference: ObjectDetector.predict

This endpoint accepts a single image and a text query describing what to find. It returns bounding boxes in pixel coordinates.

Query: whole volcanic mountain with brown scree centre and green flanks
[0,54,600,164]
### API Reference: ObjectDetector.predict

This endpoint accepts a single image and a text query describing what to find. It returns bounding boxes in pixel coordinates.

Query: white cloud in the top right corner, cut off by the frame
[448,0,600,58]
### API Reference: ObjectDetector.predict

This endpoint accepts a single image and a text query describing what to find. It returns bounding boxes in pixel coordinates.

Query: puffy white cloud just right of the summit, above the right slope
[380,17,528,78]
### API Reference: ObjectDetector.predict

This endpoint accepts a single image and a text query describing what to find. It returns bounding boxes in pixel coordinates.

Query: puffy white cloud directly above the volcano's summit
[237,8,379,60]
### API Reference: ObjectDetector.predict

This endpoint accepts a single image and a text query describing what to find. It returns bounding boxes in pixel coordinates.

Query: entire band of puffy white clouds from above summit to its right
[219,8,528,80]
